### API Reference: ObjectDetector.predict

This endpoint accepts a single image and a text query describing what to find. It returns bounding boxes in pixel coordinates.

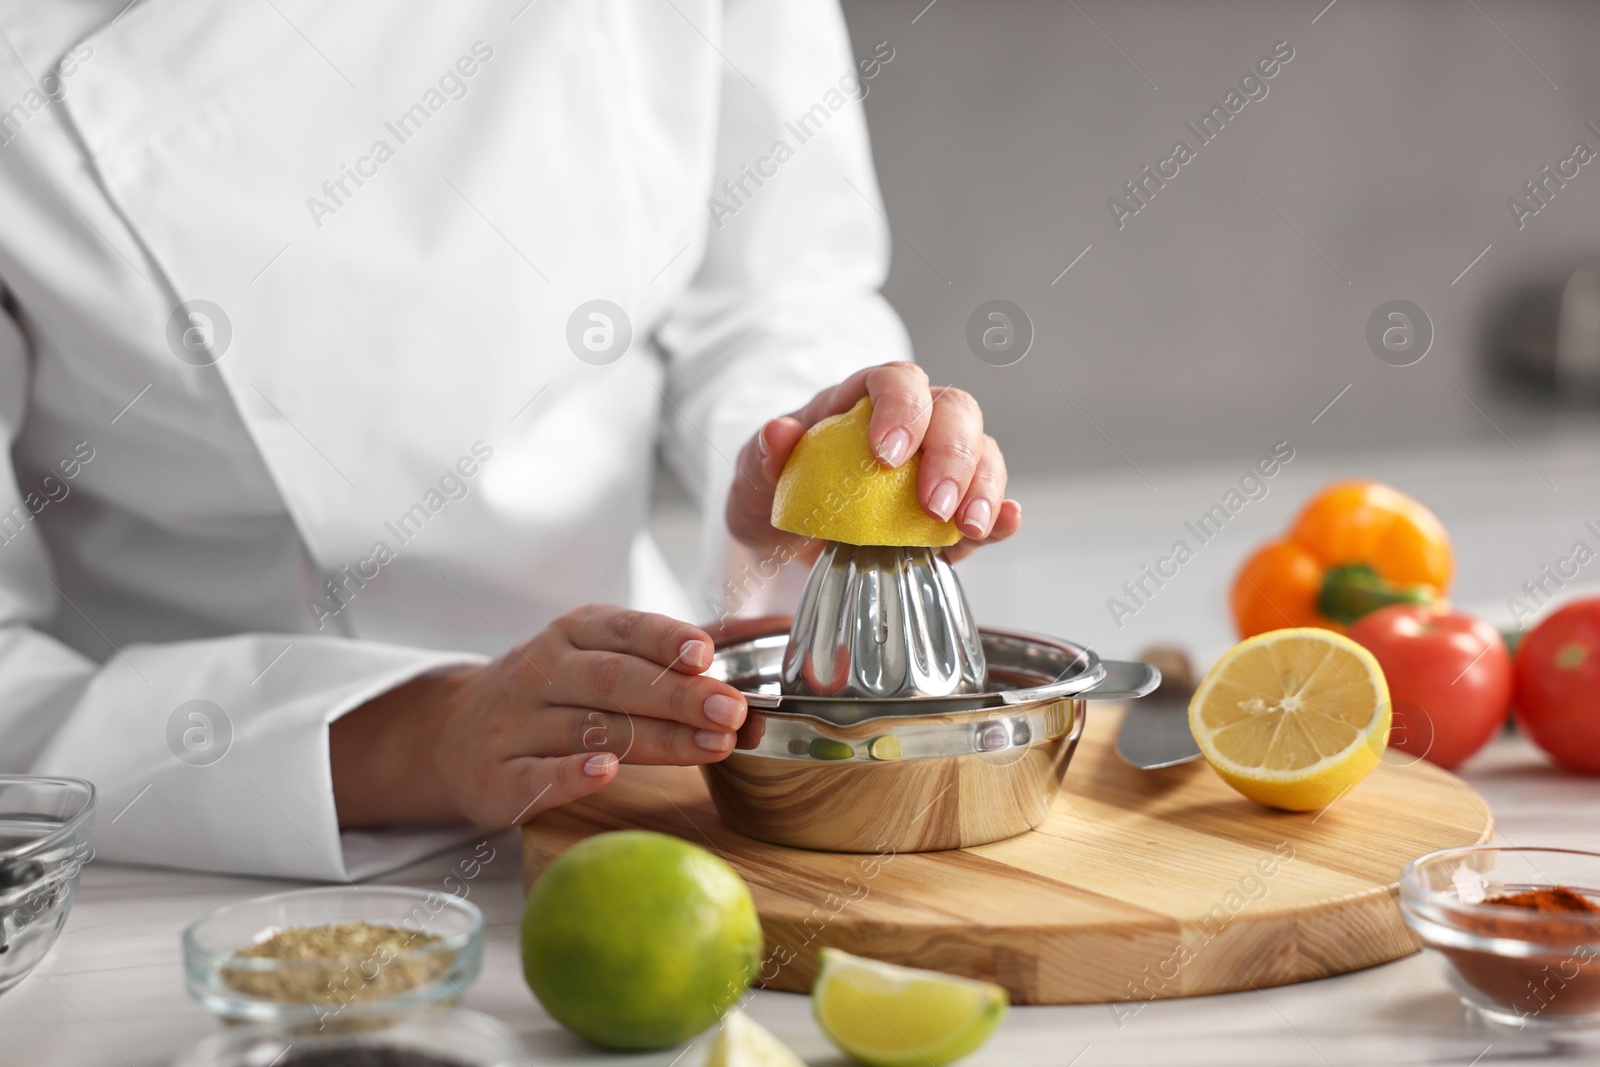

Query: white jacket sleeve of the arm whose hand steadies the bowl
[0,292,486,880]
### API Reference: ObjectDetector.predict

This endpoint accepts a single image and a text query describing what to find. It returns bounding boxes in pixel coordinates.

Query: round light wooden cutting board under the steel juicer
[523,705,1493,1009]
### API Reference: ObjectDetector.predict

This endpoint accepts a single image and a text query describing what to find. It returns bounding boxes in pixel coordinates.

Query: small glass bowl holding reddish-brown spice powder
[1400,846,1600,1030]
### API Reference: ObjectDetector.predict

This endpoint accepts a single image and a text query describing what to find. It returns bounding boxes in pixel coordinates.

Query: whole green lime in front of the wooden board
[522,830,762,1049]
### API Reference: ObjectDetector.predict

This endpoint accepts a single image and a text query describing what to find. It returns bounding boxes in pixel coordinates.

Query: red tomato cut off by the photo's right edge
[1517,597,1600,774]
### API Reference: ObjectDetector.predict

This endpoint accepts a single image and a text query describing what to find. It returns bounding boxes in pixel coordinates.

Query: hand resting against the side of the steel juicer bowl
[330,605,746,829]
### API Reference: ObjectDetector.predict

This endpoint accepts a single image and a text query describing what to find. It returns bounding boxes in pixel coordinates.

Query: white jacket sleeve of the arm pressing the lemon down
[656,0,910,619]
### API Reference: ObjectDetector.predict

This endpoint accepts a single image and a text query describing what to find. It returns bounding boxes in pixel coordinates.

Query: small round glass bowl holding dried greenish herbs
[182,886,483,1033]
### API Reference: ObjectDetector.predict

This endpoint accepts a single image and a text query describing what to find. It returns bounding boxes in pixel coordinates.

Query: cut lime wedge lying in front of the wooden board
[811,949,1008,1067]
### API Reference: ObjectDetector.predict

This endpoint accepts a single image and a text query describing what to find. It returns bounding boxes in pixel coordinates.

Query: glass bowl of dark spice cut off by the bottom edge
[174,1009,533,1067]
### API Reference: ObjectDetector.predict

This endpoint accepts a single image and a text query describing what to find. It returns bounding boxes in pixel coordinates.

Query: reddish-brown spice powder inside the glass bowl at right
[1440,886,1600,1019]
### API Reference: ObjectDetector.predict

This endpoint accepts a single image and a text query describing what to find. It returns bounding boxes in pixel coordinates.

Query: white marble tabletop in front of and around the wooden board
[0,737,1600,1067]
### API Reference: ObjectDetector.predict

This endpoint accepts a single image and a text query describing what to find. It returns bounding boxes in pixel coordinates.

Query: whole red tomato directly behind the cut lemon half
[1349,605,1512,768]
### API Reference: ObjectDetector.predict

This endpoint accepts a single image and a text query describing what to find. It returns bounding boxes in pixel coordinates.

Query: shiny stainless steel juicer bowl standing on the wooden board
[702,616,1160,853]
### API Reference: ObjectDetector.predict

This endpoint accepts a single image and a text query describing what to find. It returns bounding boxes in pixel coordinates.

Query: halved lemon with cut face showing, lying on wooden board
[1189,627,1390,811]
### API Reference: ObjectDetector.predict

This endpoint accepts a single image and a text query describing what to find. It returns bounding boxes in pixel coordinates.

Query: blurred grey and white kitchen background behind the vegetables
[653,0,1600,657]
